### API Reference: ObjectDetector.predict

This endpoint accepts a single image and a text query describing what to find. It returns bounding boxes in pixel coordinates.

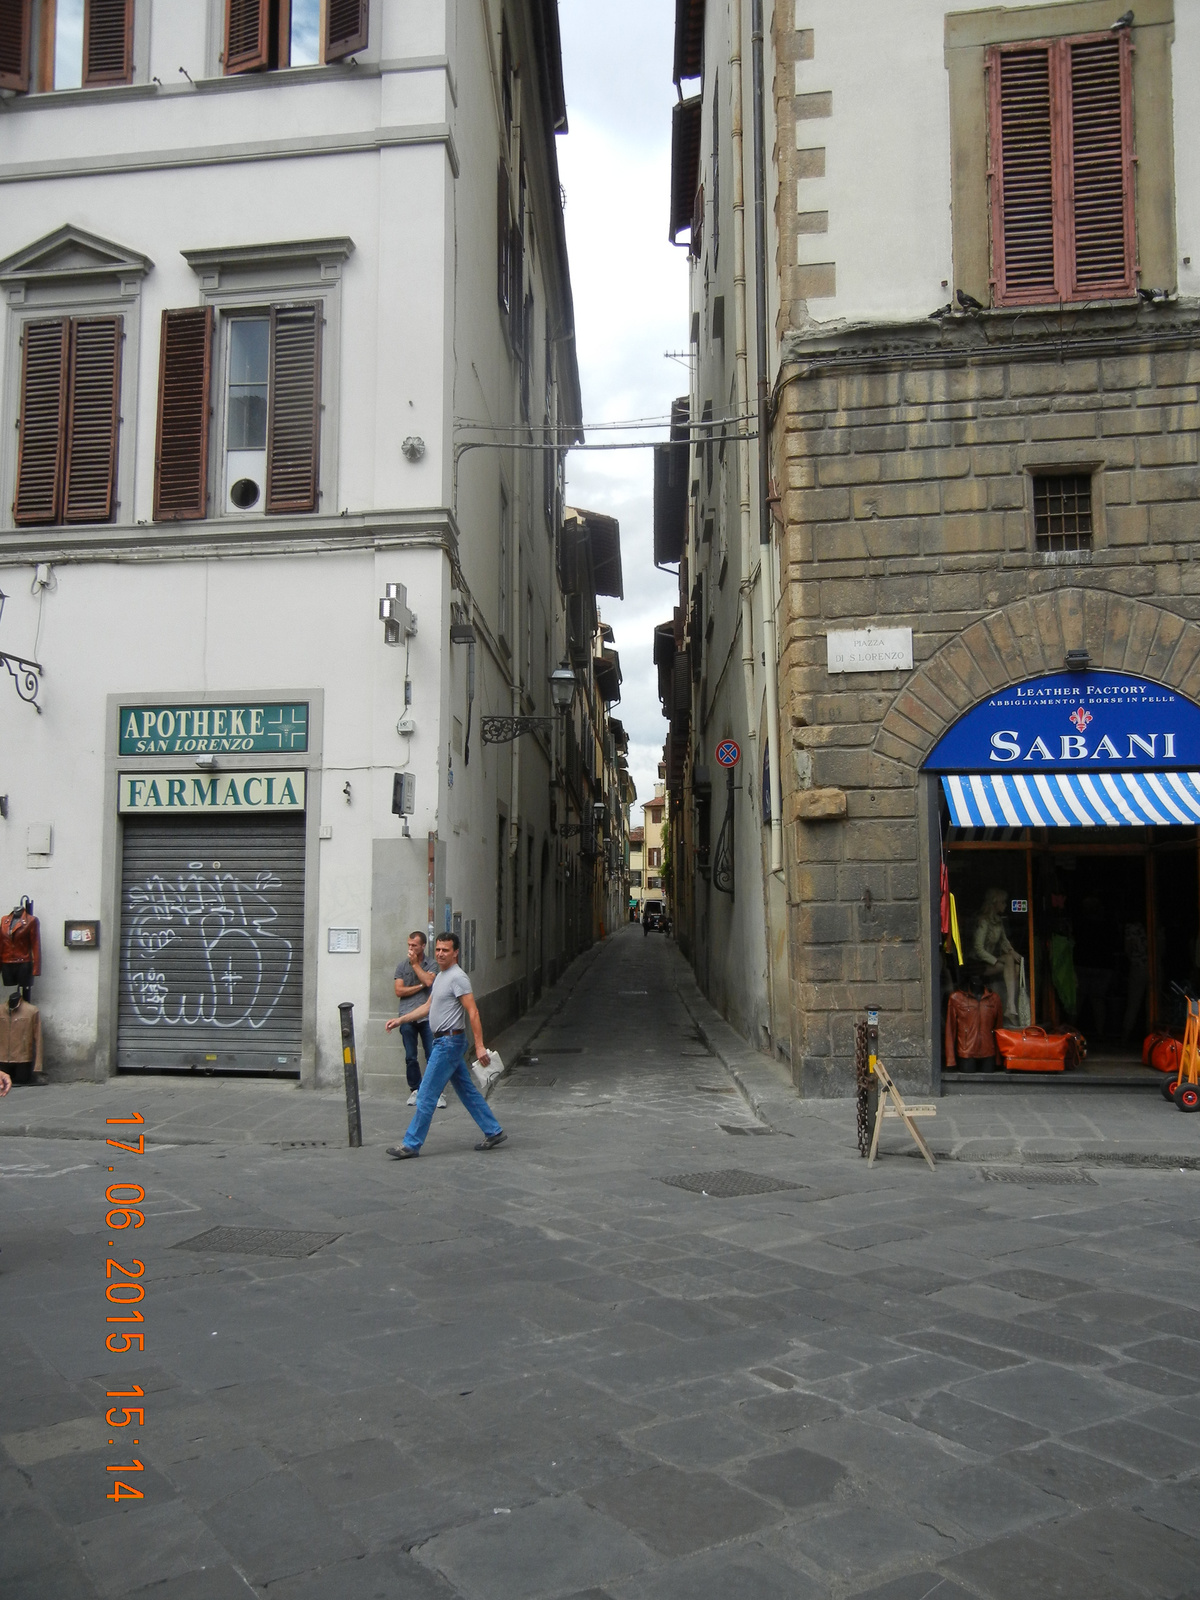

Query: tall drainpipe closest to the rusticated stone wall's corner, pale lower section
[750,0,784,872]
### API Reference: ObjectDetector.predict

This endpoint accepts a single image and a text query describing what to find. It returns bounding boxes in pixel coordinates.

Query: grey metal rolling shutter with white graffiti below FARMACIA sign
[117,816,304,1074]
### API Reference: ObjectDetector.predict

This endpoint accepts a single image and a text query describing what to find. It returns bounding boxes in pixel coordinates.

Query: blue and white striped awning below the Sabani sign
[942,773,1200,827]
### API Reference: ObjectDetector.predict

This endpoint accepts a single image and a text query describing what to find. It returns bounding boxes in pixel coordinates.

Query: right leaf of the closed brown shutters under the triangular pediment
[62,317,123,522]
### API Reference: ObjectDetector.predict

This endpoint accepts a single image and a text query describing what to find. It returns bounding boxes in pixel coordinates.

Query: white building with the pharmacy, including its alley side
[0,0,590,1086]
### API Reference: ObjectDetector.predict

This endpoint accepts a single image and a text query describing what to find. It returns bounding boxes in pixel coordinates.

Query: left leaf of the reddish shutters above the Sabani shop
[989,45,1058,306]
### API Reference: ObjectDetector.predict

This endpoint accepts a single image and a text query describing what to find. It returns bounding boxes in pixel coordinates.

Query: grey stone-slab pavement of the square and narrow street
[0,928,1200,1600]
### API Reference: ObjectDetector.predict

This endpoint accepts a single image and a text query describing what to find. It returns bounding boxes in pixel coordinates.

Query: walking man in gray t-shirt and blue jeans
[387,933,507,1162]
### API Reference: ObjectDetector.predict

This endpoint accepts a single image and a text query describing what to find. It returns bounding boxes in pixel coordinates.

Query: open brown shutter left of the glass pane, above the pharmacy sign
[154,306,213,522]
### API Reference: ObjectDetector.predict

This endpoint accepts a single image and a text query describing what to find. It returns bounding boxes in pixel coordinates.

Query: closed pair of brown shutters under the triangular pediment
[13,317,125,526]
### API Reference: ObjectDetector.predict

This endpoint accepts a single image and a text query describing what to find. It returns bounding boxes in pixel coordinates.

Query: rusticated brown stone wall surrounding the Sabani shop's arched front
[773,307,1200,1094]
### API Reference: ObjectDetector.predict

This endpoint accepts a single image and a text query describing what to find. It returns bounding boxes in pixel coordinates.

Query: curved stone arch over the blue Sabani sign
[872,589,1200,781]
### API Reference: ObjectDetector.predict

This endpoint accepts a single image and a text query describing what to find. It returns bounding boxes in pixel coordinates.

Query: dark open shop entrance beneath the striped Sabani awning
[941,827,1200,1083]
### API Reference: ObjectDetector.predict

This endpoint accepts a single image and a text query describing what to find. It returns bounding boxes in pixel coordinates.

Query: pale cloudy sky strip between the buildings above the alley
[558,0,688,827]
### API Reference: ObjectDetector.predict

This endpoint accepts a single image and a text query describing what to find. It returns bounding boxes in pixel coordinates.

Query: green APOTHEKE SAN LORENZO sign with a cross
[118,701,309,755]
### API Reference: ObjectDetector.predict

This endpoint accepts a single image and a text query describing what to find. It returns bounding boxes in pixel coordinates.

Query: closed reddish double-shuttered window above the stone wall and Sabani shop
[987,27,1138,306]
